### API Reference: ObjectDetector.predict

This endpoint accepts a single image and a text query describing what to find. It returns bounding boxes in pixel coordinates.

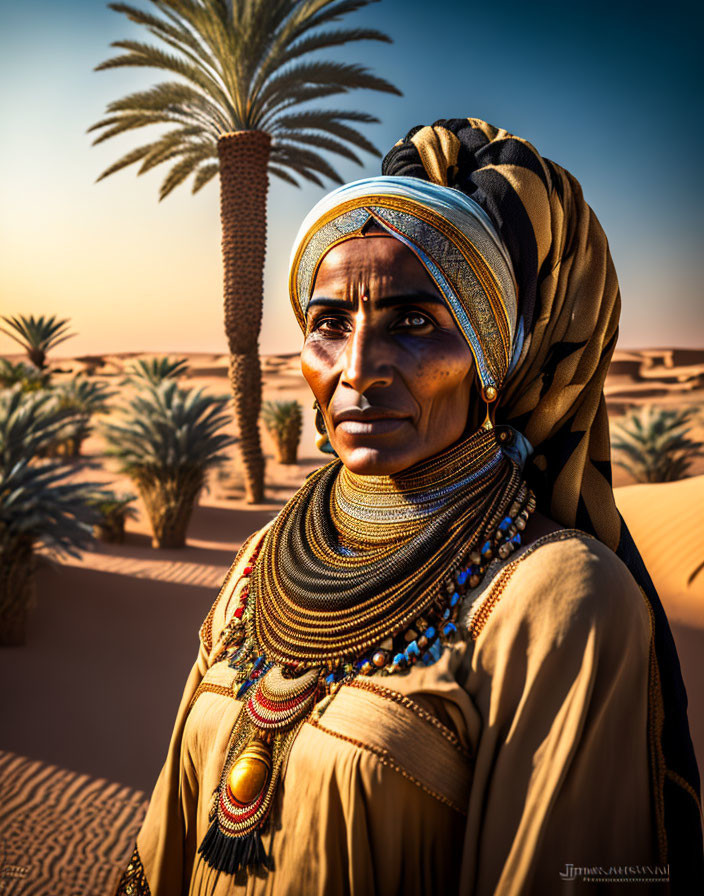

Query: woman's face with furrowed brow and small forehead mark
[301,233,474,475]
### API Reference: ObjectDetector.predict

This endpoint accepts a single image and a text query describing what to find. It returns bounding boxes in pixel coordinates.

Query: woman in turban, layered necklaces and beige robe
[118,119,704,896]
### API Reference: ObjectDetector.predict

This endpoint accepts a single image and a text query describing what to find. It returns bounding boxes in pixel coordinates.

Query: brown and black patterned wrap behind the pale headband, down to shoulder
[383,119,621,550]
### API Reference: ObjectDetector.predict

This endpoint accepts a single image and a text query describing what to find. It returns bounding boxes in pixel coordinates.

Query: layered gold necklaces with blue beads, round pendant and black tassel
[199,429,535,874]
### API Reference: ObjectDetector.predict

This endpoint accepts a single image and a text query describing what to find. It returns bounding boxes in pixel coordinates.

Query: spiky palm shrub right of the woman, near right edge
[611,405,704,482]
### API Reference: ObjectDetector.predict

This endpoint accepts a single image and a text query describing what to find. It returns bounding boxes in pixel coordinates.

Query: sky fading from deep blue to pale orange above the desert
[0,0,704,354]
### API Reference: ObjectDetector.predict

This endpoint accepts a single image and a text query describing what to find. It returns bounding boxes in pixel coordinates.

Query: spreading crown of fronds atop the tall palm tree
[89,0,399,199]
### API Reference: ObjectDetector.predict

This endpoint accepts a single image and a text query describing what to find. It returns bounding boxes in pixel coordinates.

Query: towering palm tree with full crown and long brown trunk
[90,0,400,502]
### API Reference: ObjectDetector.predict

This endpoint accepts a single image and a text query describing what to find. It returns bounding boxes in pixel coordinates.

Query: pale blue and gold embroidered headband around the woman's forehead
[290,177,520,398]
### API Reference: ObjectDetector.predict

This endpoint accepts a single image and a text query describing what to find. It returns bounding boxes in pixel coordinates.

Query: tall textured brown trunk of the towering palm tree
[218,131,271,504]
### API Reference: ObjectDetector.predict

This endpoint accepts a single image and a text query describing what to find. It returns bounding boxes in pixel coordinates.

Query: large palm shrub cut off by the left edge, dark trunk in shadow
[0,386,104,645]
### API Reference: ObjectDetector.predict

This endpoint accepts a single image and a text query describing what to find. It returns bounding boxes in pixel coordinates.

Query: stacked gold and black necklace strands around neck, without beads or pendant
[250,430,519,668]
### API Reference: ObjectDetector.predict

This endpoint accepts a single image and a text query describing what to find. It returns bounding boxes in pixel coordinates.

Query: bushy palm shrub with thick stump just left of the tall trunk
[104,379,234,548]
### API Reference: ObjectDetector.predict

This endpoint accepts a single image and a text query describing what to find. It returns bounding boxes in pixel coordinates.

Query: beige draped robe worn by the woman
[129,530,666,896]
